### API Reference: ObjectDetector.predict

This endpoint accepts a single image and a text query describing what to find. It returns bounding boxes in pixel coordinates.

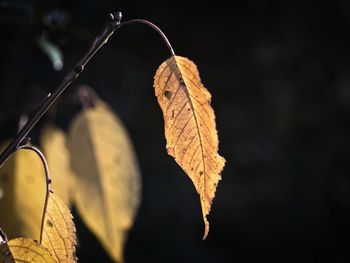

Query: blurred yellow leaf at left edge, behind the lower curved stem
[0,144,46,240]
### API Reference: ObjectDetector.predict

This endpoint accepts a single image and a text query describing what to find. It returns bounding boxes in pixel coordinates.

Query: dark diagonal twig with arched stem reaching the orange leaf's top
[0,12,175,167]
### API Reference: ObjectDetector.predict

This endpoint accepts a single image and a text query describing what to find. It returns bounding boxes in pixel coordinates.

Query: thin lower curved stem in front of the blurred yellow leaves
[19,145,53,244]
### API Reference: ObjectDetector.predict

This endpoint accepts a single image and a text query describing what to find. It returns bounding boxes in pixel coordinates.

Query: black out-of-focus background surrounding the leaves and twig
[0,0,350,263]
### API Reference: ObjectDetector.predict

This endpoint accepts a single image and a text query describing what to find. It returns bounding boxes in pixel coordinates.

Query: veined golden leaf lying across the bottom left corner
[0,238,56,263]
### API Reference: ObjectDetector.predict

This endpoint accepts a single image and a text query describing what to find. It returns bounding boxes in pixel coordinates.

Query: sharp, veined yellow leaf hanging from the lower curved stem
[41,193,77,263]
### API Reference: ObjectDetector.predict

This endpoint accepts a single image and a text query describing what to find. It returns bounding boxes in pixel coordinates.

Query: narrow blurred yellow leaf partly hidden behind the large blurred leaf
[40,125,73,207]
